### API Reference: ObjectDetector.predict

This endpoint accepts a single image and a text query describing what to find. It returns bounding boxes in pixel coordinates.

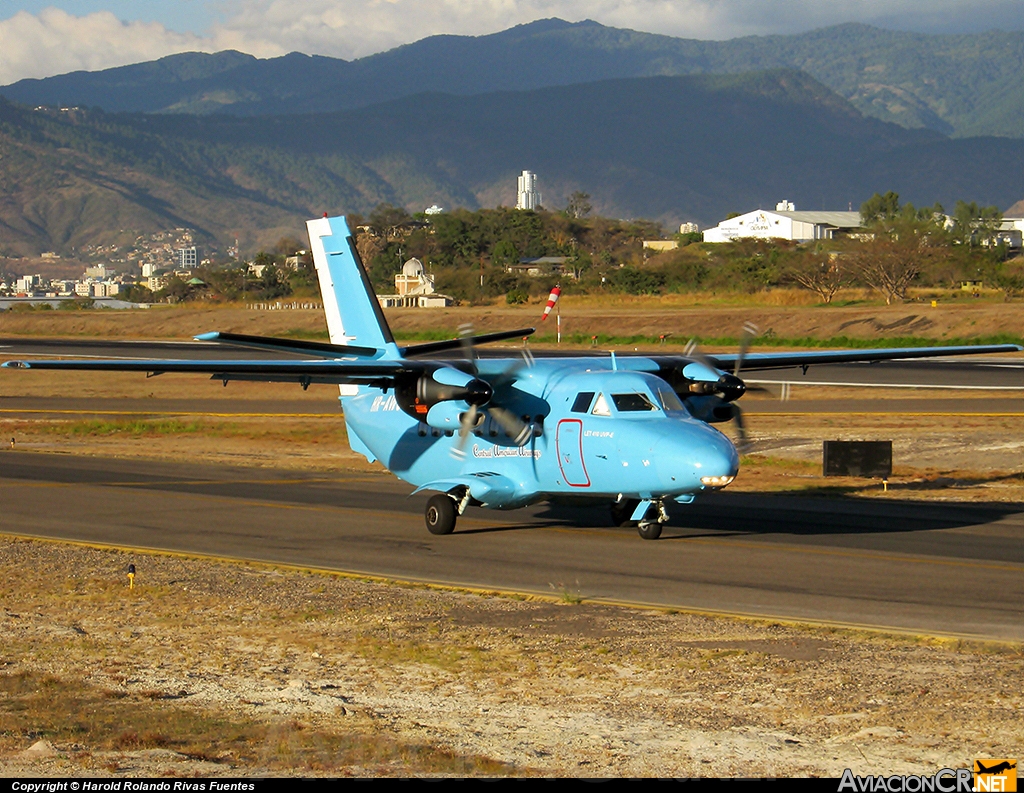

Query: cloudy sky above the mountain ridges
[0,0,1024,85]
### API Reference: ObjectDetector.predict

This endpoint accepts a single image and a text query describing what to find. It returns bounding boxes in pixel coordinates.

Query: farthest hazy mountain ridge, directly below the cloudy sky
[8,19,1024,137]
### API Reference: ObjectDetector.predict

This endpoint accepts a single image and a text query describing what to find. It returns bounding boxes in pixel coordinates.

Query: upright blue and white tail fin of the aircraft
[306,217,401,358]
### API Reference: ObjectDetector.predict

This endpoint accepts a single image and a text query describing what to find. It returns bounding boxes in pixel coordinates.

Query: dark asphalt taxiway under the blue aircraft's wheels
[0,451,1024,641]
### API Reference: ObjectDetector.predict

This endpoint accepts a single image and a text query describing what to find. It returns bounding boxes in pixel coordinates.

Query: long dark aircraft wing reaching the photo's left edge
[0,359,415,385]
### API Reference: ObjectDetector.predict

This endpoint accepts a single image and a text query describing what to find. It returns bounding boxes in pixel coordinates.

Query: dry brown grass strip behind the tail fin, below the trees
[0,290,1024,346]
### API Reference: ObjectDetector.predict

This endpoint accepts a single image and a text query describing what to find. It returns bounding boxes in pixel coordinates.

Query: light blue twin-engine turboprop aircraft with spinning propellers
[3,216,1020,539]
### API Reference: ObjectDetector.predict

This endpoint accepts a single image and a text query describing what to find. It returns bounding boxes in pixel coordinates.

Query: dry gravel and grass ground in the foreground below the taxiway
[0,536,1024,777]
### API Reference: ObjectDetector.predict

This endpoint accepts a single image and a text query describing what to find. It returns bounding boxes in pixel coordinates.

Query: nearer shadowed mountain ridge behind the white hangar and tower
[0,70,1024,258]
